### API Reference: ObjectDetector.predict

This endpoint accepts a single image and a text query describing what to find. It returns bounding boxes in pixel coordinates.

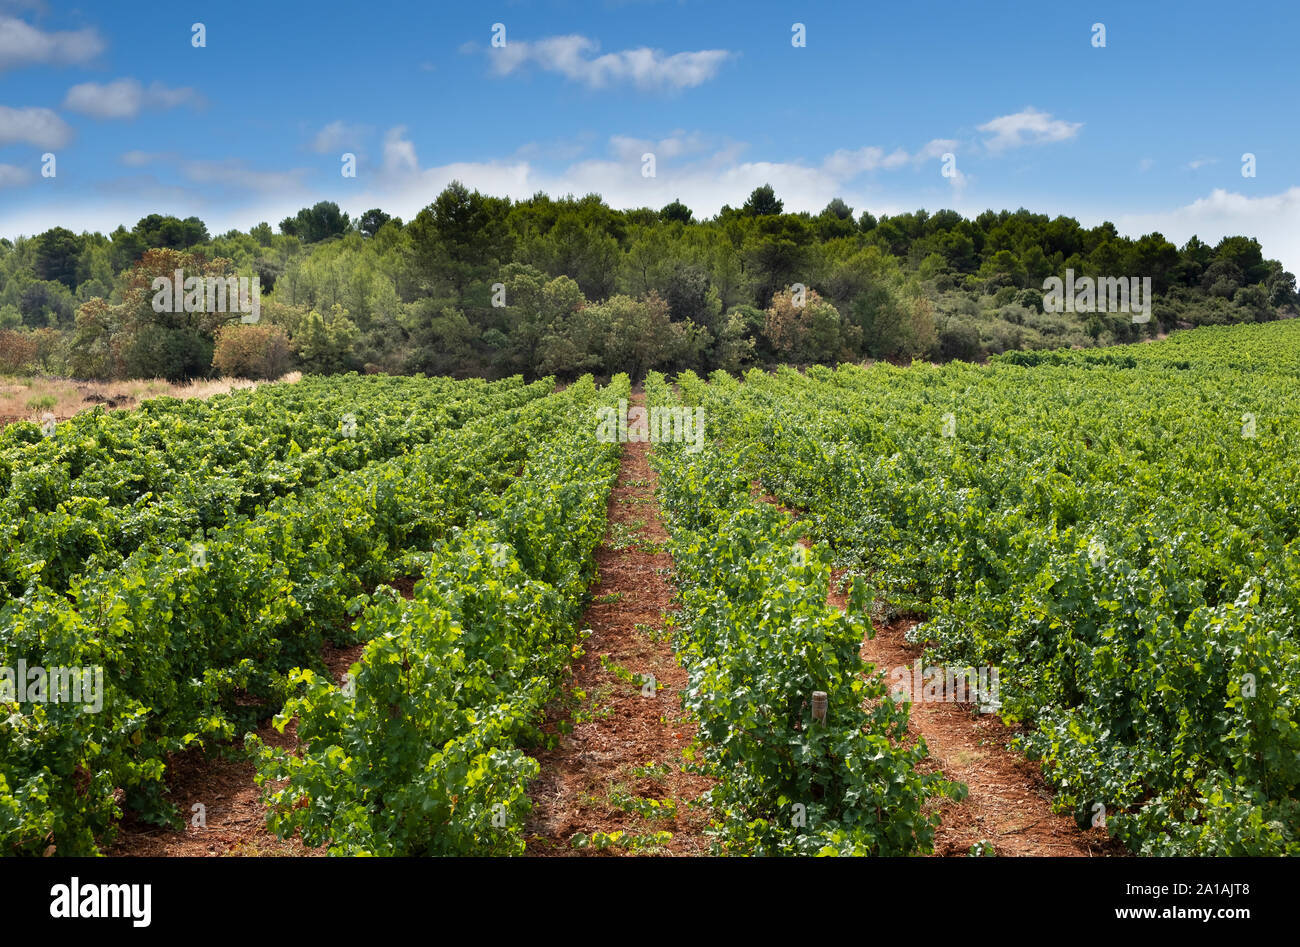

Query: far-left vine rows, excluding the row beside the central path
[0,376,592,855]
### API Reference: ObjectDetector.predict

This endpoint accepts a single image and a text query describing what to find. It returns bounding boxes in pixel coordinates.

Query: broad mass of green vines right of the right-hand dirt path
[696,321,1300,855]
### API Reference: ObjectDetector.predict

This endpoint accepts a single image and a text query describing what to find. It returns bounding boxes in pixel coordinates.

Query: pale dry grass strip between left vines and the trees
[0,372,302,424]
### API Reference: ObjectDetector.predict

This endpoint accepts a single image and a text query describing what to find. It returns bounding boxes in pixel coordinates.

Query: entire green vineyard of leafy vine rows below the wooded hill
[0,323,1300,855]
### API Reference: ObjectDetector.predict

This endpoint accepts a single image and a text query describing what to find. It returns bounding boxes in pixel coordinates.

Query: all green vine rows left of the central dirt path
[0,376,628,855]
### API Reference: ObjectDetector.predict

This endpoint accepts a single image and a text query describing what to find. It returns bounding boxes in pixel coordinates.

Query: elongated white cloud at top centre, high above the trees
[483,34,735,90]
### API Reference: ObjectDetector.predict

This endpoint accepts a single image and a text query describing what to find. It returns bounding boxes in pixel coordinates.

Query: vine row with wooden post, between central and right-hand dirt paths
[646,375,965,855]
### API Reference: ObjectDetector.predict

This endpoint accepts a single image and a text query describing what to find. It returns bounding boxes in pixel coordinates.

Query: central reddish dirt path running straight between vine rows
[525,394,711,856]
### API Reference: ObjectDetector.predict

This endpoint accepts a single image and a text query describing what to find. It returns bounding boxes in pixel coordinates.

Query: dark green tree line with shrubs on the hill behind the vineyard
[0,182,1300,380]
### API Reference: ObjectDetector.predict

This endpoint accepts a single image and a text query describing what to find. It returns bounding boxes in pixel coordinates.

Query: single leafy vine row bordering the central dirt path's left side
[248,376,629,855]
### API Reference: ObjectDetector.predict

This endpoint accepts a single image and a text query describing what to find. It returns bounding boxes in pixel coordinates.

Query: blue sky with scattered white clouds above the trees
[0,0,1300,272]
